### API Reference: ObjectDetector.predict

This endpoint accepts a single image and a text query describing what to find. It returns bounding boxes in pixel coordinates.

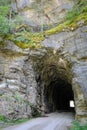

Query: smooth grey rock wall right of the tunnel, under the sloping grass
[43,26,87,122]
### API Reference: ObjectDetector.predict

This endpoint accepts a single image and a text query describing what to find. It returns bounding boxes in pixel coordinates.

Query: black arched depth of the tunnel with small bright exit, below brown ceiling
[45,78,74,113]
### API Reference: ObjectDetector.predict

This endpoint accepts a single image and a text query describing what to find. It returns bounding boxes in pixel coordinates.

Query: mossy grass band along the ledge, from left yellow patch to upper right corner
[0,0,87,49]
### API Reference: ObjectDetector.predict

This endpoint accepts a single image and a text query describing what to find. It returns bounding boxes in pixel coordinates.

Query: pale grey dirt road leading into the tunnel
[3,112,74,130]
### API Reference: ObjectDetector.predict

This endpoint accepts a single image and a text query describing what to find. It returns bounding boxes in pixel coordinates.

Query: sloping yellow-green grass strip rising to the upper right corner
[45,0,87,35]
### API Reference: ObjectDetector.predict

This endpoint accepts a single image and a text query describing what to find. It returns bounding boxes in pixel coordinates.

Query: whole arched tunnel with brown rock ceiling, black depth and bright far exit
[38,56,75,113]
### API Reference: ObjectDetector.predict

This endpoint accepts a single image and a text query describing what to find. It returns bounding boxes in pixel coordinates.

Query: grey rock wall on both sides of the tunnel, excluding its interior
[0,26,87,122]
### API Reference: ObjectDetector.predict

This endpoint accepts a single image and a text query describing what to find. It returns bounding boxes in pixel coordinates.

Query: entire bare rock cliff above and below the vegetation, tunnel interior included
[0,0,87,122]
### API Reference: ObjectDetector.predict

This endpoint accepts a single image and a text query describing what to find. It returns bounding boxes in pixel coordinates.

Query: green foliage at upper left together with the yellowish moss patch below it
[0,0,44,49]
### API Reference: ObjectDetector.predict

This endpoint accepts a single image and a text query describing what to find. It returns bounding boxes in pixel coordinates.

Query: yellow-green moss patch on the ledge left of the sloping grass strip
[8,31,44,49]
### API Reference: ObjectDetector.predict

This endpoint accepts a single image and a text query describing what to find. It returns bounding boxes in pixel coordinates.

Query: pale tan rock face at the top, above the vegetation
[12,0,73,26]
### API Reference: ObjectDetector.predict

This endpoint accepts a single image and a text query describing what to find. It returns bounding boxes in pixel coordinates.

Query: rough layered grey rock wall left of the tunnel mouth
[0,41,37,119]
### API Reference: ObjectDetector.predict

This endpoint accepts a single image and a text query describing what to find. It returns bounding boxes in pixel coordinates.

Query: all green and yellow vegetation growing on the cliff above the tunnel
[0,0,87,49]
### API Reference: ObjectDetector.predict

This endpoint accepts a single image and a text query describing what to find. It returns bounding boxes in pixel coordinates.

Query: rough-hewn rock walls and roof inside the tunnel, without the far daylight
[32,48,74,113]
